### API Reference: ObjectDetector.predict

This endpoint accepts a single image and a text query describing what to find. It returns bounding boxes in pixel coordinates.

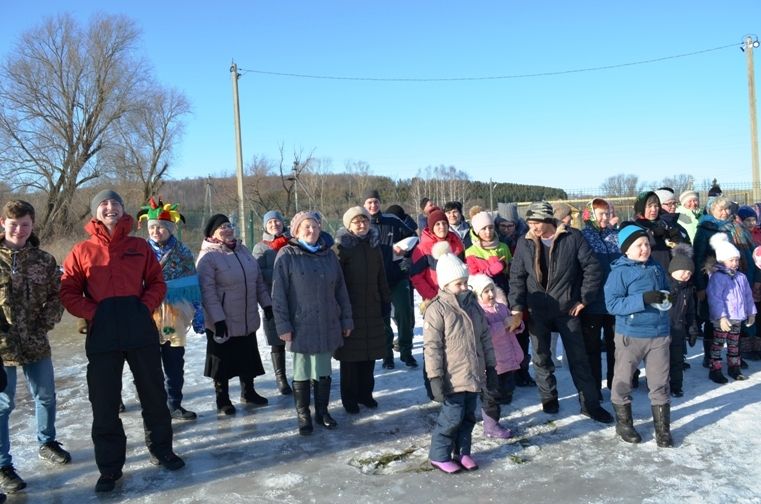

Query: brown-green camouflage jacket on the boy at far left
[0,233,63,366]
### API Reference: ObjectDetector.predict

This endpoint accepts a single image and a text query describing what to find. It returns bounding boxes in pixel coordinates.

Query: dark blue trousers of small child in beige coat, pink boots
[428,392,478,462]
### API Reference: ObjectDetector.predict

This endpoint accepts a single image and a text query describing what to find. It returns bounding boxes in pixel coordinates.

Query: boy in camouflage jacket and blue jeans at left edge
[0,200,71,492]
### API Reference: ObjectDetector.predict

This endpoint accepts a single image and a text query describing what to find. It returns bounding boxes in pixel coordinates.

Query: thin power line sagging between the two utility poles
[239,43,738,82]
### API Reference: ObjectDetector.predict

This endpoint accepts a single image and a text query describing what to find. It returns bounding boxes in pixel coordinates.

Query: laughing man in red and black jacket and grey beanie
[61,190,185,492]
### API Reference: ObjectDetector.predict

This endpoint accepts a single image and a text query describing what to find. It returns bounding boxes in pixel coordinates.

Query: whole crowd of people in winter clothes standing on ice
[0,180,761,492]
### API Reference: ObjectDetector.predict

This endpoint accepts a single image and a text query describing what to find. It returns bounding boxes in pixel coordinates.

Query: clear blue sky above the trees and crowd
[0,0,761,189]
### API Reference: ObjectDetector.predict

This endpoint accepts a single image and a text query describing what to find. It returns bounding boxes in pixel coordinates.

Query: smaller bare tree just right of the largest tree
[108,85,190,201]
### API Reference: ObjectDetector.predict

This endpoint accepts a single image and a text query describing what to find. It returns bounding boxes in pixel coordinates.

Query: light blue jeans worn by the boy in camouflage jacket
[0,357,55,467]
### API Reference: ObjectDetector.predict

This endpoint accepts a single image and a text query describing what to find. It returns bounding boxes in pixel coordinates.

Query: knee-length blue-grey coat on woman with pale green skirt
[272,238,354,354]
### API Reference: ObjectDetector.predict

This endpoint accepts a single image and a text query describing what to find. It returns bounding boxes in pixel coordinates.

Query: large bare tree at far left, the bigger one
[0,15,146,236]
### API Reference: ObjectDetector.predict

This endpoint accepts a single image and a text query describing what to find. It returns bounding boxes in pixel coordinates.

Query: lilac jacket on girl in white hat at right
[706,264,756,321]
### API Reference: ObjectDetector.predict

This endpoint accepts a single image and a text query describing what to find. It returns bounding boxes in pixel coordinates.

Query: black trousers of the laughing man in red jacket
[87,342,172,474]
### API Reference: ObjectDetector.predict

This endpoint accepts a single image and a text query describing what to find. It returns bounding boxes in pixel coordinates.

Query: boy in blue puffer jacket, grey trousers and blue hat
[605,223,673,447]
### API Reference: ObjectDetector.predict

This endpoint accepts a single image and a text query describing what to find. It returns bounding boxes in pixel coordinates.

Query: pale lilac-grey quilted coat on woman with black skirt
[196,240,272,336]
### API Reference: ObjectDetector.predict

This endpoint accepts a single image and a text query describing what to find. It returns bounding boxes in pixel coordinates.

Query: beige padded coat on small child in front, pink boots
[423,290,497,394]
